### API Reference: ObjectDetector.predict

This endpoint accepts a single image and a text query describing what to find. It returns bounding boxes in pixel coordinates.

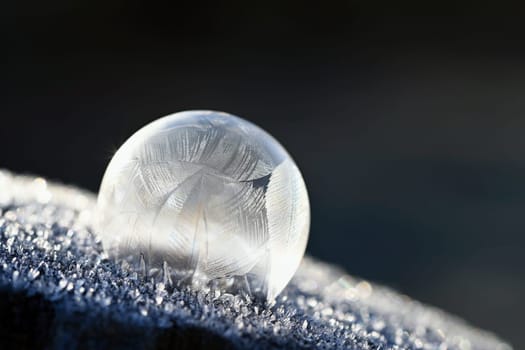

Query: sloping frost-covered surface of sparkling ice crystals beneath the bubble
[0,171,510,350]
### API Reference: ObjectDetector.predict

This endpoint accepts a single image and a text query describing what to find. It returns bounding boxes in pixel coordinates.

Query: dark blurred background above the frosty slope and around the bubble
[0,0,525,348]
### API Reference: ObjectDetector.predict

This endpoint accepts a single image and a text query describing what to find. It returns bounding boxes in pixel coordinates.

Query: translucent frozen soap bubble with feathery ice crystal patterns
[97,111,310,300]
